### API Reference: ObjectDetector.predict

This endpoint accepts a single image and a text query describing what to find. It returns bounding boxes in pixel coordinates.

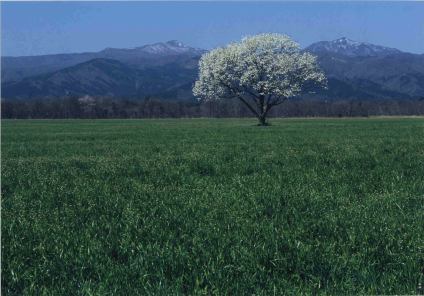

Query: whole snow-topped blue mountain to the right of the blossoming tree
[305,38,424,99]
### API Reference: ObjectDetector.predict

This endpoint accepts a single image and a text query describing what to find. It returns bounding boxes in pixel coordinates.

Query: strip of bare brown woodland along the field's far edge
[1,96,424,119]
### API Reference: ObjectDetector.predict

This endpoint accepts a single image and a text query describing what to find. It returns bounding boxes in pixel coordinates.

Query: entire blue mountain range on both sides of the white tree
[1,37,424,100]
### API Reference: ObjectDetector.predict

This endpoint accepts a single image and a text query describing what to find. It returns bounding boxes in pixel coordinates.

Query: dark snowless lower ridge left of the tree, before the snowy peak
[2,58,196,99]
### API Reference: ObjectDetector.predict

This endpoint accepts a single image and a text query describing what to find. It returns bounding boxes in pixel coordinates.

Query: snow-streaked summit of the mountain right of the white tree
[306,37,401,57]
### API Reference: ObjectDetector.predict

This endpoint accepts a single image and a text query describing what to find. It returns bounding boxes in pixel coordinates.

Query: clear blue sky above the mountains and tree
[1,2,424,56]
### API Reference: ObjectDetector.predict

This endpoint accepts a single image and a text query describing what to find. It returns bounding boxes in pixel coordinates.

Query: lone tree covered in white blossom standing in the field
[193,34,326,125]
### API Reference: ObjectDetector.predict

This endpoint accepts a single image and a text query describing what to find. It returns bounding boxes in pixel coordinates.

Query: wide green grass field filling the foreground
[1,118,424,295]
